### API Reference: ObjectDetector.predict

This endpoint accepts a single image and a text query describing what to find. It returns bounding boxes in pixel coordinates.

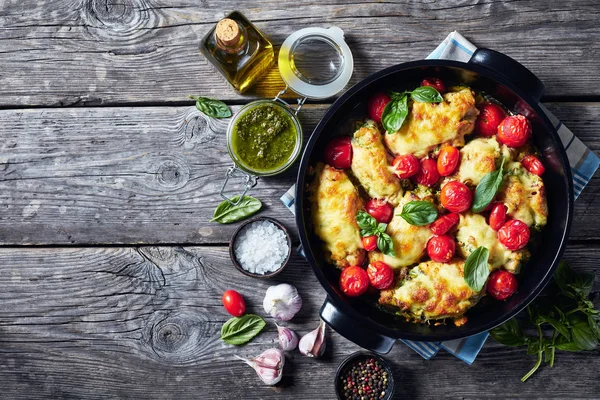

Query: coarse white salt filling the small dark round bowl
[233,221,290,275]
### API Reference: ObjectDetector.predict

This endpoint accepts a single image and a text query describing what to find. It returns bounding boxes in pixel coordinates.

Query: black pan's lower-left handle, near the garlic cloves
[320,297,396,354]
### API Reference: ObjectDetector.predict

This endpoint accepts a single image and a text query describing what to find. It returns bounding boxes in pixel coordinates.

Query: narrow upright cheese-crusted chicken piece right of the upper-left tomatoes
[352,121,402,205]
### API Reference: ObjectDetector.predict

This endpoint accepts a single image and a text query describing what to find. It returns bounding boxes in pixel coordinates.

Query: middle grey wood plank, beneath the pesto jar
[0,103,600,245]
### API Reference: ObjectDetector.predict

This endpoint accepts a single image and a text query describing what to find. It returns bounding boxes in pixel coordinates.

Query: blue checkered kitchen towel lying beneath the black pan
[281,31,600,364]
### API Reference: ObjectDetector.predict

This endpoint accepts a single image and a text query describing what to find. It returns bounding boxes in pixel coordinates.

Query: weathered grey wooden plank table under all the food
[0,0,600,399]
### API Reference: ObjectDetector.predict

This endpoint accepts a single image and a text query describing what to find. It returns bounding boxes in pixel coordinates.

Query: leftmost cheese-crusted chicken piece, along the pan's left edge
[309,163,364,268]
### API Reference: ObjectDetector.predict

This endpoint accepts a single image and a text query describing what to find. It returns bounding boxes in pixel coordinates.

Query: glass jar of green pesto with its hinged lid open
[220,27,353,205]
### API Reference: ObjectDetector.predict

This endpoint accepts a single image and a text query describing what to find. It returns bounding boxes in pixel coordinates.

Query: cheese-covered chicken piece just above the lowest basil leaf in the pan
[456,212,529,273]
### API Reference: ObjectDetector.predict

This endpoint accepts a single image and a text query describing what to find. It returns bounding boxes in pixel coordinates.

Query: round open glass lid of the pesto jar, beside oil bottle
[278,27,354,99]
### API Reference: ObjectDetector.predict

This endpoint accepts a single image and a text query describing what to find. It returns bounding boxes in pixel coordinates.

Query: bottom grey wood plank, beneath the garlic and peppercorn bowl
[0,245,600,399]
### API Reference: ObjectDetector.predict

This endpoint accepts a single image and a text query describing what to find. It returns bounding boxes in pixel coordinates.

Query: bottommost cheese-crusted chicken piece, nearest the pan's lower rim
[379,259,479,323]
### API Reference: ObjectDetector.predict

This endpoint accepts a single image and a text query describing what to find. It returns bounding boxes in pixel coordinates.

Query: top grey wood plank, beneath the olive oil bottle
[0,0,600,106]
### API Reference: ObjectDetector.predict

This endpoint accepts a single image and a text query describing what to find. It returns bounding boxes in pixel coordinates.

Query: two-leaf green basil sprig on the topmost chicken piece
[381,86,444,134]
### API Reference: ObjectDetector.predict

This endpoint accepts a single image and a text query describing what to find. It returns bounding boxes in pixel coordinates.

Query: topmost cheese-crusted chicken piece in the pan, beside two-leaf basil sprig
[384,88,479,157]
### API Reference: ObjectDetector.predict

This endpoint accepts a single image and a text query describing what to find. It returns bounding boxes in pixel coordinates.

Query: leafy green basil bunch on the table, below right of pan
[490,261,600,382]
